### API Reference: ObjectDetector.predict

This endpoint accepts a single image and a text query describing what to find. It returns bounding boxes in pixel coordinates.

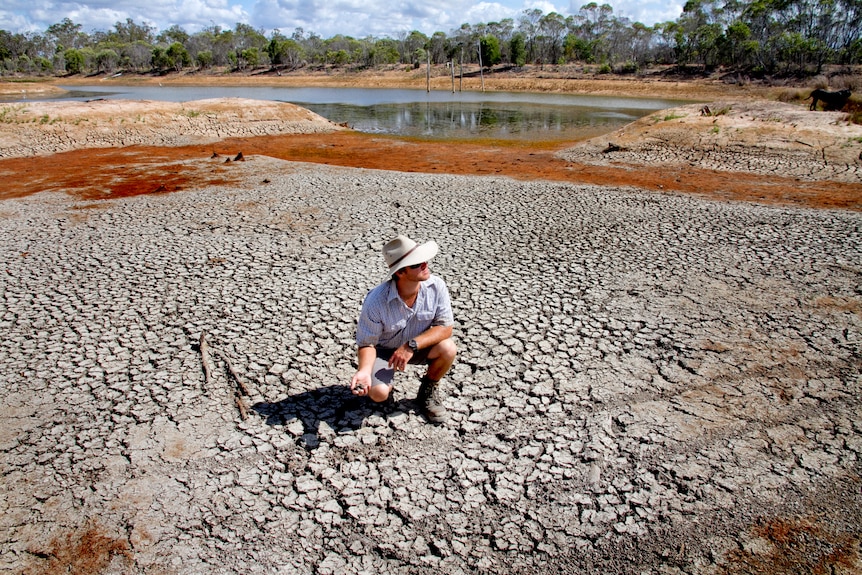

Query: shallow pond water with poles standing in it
[13,85,683,140]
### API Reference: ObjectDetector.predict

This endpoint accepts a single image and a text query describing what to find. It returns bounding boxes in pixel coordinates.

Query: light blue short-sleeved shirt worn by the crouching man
[356,275,455,349]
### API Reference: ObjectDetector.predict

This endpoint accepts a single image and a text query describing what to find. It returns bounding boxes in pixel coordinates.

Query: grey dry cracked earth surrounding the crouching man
[0,156,862,575]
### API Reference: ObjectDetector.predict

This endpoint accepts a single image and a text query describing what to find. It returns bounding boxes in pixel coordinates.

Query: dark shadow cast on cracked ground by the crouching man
[252,385,412,449]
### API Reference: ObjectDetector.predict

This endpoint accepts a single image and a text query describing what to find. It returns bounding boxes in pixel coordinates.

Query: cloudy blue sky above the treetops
[0,0,684,38]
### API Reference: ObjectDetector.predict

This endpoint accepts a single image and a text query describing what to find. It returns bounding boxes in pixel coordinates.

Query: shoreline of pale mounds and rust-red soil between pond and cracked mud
[0,92,862,210]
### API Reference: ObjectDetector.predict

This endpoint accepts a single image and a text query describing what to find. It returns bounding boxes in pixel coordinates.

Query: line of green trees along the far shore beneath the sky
[5,0,862,76]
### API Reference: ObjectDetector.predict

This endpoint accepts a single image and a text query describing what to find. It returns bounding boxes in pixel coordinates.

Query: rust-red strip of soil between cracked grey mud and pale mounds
[0,132,862,211]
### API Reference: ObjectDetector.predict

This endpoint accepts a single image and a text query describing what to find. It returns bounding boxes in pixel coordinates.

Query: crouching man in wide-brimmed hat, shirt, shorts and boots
[350,236,456,423]
